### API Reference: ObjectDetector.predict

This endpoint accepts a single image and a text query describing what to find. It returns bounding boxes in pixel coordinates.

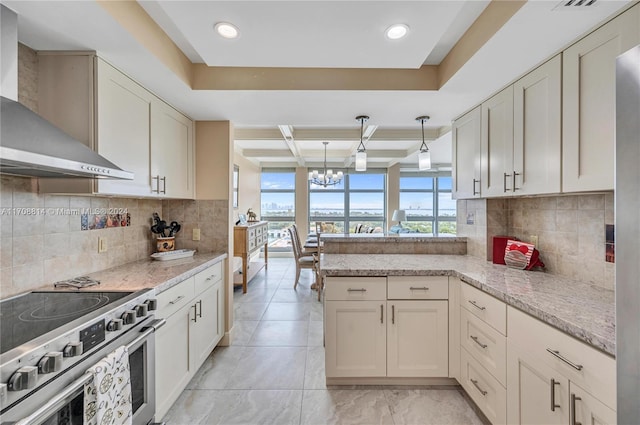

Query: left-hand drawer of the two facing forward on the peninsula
[324,277,387,301]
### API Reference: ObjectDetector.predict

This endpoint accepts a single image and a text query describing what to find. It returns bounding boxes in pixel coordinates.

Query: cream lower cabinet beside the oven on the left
[155,263,224,420]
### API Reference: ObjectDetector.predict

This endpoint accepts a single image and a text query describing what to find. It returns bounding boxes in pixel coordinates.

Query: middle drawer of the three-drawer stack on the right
[460,309,507,387]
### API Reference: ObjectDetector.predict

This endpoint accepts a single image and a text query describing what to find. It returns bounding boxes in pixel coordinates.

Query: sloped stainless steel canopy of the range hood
[0,96,133,180]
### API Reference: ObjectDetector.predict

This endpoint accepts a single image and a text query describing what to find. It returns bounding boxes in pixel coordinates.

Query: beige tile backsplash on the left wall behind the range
[0,175,162,298]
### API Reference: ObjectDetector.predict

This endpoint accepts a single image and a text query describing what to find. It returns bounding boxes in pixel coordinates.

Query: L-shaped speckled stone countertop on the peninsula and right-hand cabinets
[320,254,616,356]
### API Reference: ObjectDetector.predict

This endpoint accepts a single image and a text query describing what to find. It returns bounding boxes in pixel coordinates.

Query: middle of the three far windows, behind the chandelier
[309,170,386,233]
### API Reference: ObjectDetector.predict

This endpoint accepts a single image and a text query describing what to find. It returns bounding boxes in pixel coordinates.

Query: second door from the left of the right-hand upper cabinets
[480,86,513,197]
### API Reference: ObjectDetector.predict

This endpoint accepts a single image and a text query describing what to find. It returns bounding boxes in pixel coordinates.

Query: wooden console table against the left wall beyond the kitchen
[233,221,269,294]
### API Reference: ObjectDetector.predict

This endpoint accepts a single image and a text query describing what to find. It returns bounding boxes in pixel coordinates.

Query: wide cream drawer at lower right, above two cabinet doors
[507,307,616,410]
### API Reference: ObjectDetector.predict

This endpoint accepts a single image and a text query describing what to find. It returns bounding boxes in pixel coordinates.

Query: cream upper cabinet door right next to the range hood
[96,59,153,196]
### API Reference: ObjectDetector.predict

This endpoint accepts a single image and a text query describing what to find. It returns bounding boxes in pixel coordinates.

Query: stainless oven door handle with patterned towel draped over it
[14,319,167,425]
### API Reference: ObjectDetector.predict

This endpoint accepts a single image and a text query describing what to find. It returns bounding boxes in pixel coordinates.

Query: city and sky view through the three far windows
[261,169,456,251]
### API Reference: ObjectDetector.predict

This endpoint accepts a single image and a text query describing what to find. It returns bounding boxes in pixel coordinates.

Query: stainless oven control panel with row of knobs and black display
[0,291,157,413]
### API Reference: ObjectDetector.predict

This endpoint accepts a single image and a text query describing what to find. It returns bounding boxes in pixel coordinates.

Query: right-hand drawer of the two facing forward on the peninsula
[387,276,449,300]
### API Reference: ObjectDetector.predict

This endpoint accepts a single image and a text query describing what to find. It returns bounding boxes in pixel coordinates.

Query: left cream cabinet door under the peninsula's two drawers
[325,301,388,378]
